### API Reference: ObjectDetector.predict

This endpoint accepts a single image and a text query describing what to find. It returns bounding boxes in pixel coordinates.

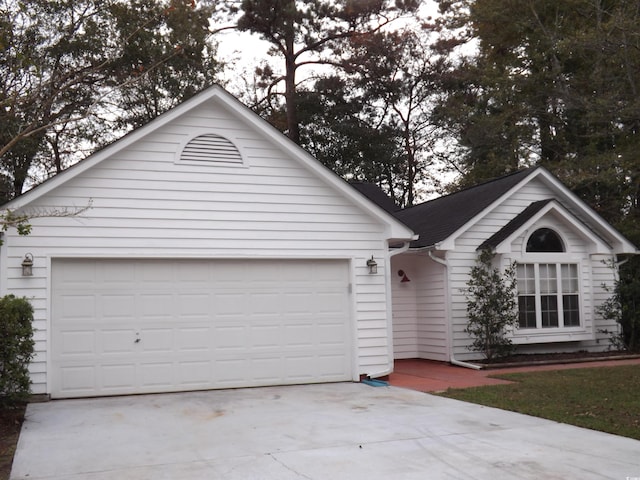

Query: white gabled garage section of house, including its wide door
[0,87,417,398]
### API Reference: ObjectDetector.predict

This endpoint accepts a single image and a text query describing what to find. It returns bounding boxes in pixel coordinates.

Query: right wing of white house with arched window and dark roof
[382,167,638,363]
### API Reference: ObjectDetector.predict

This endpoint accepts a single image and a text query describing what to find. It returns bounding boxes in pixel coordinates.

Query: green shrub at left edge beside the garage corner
[0,295,34,405]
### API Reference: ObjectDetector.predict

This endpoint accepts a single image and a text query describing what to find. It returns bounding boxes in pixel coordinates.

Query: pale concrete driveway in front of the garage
[11,383,640,480]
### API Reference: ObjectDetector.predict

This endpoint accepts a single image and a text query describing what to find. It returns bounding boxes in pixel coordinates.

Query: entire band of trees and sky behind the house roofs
[0,0,640,242]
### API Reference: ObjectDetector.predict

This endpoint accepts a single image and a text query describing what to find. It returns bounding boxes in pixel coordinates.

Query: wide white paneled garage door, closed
[51,259,352,398]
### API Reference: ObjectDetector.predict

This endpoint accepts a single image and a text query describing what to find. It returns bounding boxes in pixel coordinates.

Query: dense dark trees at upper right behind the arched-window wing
[434,0,640,240]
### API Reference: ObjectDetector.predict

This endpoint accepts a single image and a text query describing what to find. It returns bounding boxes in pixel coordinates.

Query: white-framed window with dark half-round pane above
[517,228,580,329]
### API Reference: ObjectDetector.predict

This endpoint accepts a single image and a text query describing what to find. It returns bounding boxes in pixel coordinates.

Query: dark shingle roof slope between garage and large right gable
[394,167,537,248]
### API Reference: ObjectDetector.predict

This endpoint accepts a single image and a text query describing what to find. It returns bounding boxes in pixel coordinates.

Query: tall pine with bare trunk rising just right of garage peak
[222,0,420,143]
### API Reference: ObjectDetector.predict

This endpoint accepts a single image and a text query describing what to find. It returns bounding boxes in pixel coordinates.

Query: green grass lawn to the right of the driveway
[441,365,640,440]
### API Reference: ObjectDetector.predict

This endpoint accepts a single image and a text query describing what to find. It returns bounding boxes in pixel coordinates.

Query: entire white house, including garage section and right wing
[0,87,636,398]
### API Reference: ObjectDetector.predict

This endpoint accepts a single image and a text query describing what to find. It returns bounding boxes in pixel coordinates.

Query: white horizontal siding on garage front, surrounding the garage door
[1,99,400,393]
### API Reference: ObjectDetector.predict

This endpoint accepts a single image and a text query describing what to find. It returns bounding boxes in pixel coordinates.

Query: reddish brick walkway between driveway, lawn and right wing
[389,358,640,392]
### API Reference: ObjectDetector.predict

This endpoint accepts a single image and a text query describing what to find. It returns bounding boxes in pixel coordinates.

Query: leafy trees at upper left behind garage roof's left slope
[0,0,218,200]
